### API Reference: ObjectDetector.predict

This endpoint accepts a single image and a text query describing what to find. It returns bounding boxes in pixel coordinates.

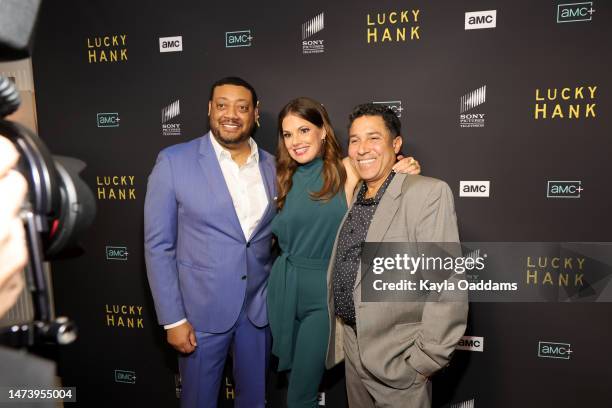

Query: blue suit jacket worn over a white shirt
[144,133,276,333]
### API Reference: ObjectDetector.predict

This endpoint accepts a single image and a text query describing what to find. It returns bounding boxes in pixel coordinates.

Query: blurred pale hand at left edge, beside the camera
[0,136,28,317]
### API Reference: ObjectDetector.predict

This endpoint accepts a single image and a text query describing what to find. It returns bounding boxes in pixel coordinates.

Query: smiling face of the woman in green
[282,114,326,164]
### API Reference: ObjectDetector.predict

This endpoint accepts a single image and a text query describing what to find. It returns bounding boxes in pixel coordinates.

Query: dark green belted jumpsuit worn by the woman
[268,158,347,408]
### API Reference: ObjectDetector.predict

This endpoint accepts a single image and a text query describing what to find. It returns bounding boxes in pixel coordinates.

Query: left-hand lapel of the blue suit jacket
[198,132,245,241]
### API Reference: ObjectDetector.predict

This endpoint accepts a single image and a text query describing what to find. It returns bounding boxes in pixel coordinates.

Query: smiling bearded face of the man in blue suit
[208,85,259,146]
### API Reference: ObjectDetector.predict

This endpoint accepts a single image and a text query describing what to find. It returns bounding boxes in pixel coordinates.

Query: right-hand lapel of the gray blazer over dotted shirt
[353,174,406,289]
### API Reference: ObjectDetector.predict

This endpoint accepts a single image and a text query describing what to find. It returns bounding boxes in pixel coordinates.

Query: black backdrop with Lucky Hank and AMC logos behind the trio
[33,0,612,407]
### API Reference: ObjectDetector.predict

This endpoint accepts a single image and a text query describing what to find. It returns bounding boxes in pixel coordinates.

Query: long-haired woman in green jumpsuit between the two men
[268,98,419,408]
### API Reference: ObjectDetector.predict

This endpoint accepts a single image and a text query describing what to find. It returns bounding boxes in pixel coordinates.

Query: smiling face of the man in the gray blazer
[348,115,402,189]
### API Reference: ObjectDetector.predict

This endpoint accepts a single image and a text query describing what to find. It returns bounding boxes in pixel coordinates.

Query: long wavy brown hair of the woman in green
[276,97,346,209]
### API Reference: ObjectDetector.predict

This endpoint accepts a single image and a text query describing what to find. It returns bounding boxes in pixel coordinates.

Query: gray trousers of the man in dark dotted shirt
[344,325,431,408]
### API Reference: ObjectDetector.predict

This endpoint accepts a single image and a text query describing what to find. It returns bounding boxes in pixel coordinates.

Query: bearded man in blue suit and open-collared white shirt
[145,77,276,408]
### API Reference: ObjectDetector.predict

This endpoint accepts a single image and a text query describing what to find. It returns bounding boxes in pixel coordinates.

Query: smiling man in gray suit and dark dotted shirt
[326,104,468,408]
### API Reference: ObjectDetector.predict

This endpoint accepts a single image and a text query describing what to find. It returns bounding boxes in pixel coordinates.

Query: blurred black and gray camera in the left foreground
[0,0,96,347]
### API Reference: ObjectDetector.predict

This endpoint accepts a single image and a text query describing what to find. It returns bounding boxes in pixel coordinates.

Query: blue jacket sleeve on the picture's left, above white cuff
[144,152,186,325]
